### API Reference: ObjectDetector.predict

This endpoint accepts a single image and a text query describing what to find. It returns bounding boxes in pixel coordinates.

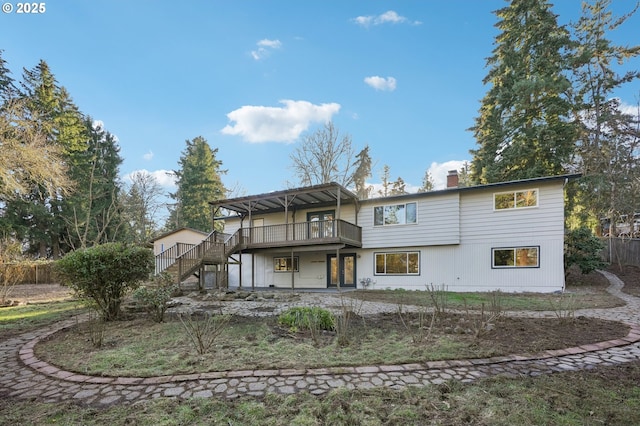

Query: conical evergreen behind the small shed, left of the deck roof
[169,136,226,231]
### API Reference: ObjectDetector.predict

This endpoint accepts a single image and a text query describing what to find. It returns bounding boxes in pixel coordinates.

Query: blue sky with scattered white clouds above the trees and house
[0,0,640,200]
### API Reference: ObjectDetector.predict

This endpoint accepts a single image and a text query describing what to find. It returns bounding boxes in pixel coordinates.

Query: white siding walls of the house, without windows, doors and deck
[225,180,564,292]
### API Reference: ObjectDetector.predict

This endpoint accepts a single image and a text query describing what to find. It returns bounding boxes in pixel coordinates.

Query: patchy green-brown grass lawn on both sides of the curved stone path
[0,270,640,426]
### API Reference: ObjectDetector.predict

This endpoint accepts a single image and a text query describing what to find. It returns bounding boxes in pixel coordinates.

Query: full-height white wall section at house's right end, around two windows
[456,181,564,292]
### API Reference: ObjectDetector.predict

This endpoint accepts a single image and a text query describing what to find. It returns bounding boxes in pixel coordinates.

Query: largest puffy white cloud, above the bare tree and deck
[221,99,340,143]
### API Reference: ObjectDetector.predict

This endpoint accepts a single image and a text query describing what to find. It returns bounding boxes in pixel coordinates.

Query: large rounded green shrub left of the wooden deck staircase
[54,243,153,321]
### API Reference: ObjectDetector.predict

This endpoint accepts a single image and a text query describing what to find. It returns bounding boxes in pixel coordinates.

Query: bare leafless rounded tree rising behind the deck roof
[290,122,356,187]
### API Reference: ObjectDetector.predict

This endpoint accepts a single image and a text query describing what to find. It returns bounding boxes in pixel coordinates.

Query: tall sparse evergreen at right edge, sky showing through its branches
[569,0,640,233]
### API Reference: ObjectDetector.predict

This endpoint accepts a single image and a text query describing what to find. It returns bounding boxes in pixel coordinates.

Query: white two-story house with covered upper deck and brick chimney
[156,171,577,292]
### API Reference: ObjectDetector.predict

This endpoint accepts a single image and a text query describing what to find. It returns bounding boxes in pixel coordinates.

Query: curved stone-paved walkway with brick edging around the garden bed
[0,272,640,406]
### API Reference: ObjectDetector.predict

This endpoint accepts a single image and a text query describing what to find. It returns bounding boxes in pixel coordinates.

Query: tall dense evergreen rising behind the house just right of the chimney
[471,0,576,183]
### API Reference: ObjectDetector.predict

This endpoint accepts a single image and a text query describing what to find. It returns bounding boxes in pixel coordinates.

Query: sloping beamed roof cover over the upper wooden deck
[209,182,358,214]
